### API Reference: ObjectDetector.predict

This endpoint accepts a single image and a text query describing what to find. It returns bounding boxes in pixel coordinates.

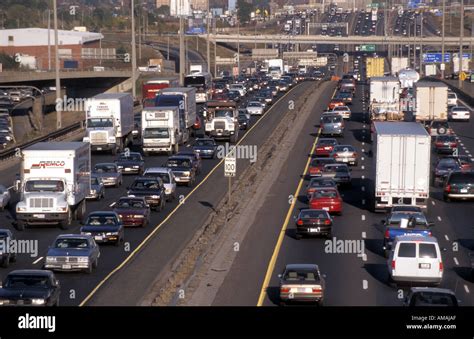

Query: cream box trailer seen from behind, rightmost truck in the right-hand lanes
[414,81,448,121]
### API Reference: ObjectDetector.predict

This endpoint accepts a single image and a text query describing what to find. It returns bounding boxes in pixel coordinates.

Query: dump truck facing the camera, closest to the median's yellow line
[205,100,240,143]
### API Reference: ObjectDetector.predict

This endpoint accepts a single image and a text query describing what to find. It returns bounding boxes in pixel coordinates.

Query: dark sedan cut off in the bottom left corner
[0,270,61,306]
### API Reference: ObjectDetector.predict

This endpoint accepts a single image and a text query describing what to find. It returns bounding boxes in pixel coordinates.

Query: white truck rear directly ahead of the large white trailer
[369,77,403,121]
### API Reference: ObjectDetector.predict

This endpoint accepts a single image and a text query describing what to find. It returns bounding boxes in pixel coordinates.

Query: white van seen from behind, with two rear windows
[387,235,444,285]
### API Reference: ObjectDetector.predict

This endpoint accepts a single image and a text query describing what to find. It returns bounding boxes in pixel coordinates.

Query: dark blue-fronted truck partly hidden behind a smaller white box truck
[155,87,196,135]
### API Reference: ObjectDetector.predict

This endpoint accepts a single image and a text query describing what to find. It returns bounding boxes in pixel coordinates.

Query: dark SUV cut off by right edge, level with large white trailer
[443,171,474,201]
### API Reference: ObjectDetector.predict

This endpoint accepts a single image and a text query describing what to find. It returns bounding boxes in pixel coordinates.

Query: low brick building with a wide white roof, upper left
[0,28,104,69]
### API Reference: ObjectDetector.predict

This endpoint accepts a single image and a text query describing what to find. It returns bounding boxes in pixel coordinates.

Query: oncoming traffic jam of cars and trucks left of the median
[0,59,328,306]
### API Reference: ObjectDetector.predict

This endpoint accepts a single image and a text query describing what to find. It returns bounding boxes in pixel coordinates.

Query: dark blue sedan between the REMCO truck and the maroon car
[81,211,125,246]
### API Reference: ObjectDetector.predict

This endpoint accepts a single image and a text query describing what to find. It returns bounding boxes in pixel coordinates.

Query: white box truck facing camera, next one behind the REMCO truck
[82,93,134,154]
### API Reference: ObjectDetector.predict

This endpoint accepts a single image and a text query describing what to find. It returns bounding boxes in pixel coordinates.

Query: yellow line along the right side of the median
[257,83,337,306]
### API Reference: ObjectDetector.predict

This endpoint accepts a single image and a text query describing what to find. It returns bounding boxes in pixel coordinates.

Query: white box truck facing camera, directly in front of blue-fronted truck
[142,106,185,155]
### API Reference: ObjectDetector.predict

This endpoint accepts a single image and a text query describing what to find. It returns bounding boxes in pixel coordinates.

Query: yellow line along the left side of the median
[79,83,308,307]
